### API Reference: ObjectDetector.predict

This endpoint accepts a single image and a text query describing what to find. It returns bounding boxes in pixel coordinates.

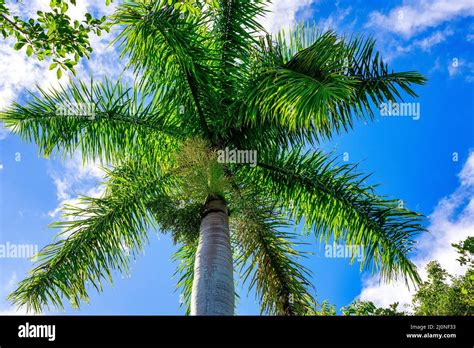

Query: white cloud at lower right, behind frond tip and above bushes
[359,152,474,307]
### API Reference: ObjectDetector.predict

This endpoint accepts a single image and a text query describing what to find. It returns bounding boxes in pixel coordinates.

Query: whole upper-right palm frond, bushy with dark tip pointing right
[238,27,426,142]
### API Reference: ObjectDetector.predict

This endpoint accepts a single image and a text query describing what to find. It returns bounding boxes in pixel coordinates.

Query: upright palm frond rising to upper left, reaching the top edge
[115,0,217,137]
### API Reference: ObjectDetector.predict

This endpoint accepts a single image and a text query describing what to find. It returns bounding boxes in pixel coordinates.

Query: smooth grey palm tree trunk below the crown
[191,198,234,315]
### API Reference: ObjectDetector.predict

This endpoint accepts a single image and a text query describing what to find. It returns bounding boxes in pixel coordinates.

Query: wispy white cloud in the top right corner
[367,0,474,38]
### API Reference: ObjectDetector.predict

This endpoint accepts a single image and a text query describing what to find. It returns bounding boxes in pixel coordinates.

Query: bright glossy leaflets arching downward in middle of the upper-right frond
[242,59,354,141]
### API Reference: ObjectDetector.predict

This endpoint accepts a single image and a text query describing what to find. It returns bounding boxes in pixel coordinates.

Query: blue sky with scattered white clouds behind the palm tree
[0,0,474,314]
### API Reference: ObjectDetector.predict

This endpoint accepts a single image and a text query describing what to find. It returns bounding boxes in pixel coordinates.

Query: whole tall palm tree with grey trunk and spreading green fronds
[0,0,425,315]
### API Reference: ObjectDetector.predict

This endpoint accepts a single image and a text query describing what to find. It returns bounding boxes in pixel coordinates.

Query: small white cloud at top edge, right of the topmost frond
[262,0,316,33]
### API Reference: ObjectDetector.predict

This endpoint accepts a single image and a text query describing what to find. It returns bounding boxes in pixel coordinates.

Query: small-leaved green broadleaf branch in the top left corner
[0,0,111,79]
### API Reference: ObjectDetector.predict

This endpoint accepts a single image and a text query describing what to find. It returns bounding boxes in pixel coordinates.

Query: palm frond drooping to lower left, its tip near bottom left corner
[9,162,174,312]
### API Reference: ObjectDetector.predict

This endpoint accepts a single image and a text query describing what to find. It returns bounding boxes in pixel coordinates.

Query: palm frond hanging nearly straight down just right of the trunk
[231,197,315,315]
